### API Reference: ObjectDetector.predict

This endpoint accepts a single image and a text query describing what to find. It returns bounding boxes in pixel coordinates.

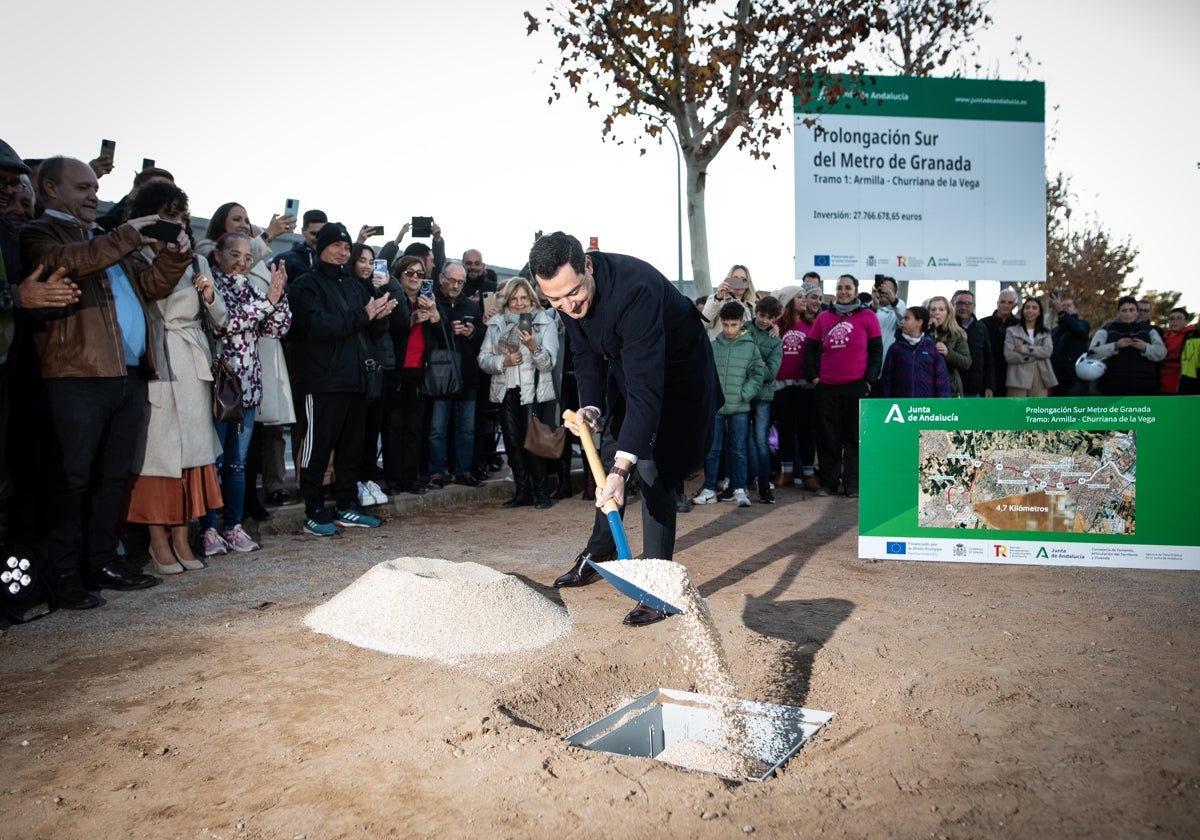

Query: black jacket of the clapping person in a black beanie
[287,263,388,394]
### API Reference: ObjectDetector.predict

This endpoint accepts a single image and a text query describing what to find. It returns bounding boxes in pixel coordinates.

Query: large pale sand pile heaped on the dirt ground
[305,557,571,665]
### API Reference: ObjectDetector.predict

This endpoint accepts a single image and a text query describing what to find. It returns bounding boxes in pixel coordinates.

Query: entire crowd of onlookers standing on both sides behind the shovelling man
[0,142,1200,610]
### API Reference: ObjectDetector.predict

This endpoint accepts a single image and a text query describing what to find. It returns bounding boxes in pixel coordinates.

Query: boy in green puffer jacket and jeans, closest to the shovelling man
[692,300,763,508]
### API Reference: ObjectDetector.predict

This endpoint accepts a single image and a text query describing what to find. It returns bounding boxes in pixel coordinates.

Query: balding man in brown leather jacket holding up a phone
[20,157,191,610]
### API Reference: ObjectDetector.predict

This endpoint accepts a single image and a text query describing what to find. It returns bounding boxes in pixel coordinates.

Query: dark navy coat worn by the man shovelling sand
[563,251,724,485]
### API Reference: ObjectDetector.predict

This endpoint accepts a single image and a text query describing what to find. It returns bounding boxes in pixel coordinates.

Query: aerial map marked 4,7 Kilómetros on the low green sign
[917,430,1136,534]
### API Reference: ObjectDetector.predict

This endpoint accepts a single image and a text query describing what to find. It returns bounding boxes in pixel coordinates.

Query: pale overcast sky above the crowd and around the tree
[0,0,1200,308]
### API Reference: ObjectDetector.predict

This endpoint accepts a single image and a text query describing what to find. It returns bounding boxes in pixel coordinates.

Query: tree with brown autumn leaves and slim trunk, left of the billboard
[526,0,887,294]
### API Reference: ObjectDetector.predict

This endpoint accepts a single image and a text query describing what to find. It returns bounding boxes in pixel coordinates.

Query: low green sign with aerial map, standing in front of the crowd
[858,397,1200,570]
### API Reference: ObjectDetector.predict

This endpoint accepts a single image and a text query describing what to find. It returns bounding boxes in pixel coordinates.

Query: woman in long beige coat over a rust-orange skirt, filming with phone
[125,181,228,575]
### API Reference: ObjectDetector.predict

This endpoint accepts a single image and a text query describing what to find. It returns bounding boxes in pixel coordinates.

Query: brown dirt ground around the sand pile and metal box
[0,488,1200,840]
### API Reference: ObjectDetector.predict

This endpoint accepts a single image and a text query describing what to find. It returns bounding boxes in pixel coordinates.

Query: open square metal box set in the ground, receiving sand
[566,689,833,781]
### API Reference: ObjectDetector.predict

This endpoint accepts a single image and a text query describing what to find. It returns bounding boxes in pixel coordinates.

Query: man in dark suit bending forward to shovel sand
[529,232,722,626]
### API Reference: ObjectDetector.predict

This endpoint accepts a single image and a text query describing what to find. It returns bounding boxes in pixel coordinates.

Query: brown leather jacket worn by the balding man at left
[20,215,192,379]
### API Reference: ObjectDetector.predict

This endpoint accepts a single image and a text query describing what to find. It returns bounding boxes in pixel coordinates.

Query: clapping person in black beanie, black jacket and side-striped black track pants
[288,222,396,536]
